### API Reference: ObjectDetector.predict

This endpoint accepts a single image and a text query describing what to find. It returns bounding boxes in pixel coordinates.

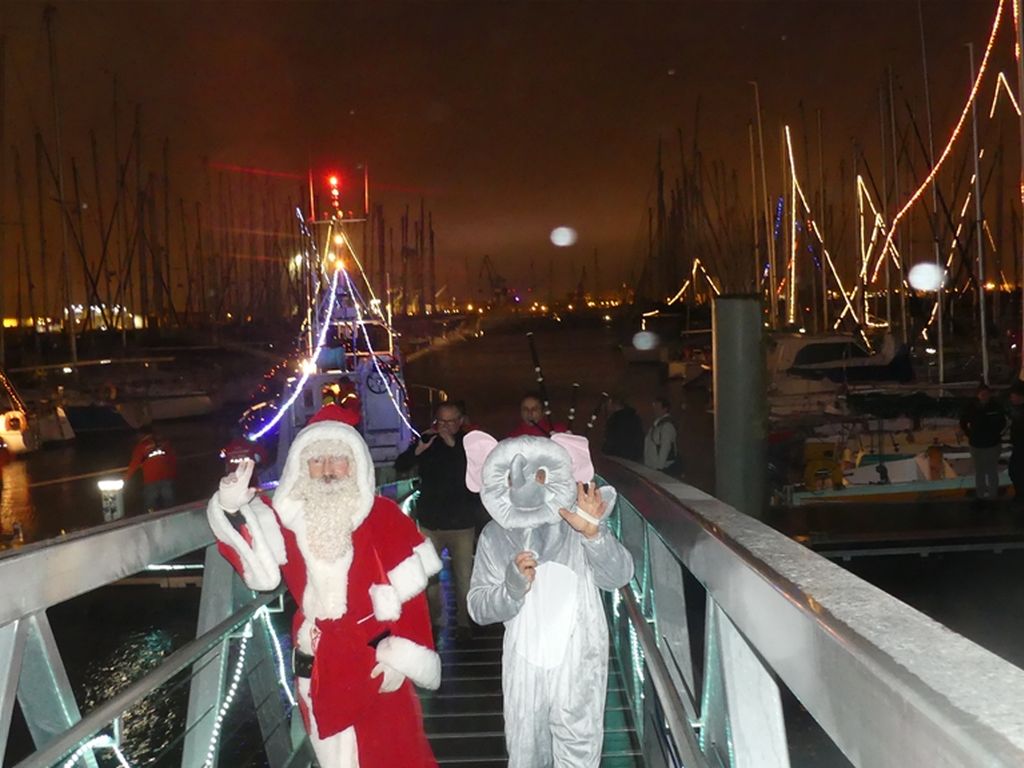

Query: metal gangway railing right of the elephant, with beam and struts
[599,461,1024,768]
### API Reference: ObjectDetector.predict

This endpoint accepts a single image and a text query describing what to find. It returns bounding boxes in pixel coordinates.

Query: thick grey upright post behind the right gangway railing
[712,296,767,517]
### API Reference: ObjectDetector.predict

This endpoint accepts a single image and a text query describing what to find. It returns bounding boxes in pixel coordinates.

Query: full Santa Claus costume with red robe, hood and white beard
[207,406,441,768]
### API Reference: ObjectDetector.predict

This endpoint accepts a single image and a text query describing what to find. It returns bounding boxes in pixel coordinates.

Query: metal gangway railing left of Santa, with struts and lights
[0,480,413,768]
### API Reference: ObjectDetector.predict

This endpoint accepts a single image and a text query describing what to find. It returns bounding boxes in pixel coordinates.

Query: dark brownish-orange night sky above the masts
[3,0,1016,303]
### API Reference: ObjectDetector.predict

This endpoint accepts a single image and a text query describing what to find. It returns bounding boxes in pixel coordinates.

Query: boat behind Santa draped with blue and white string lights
[241,207,417,483]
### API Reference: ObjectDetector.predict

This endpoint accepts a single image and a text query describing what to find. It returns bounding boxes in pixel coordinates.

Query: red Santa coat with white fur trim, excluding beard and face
[208,425,440,768]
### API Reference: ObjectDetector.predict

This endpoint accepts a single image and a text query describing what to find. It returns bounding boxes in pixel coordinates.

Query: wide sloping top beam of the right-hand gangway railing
[598,461,1024,768]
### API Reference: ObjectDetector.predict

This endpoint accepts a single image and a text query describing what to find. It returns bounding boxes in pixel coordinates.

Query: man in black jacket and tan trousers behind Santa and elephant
[394,401,480,640]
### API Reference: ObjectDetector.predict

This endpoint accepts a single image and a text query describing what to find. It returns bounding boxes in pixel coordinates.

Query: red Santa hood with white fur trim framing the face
[273,400,376,526]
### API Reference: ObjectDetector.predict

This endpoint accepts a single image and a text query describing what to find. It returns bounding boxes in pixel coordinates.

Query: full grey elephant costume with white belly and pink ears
[465,432,633,768]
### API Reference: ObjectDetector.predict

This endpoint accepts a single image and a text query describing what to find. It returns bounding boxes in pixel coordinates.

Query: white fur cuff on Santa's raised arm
[206,494,288,592]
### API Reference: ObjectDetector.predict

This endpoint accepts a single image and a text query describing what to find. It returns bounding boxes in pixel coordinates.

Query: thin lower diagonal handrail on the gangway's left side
[15,589,282,768]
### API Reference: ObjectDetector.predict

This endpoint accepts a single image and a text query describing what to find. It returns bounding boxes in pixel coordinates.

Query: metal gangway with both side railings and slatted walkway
[0,462,1024,768]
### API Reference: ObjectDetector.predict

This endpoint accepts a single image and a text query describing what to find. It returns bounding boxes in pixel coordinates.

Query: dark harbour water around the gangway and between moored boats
[8,327,1024,768]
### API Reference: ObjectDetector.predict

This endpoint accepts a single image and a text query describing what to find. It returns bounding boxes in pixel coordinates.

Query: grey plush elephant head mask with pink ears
[464,431,594,528]
